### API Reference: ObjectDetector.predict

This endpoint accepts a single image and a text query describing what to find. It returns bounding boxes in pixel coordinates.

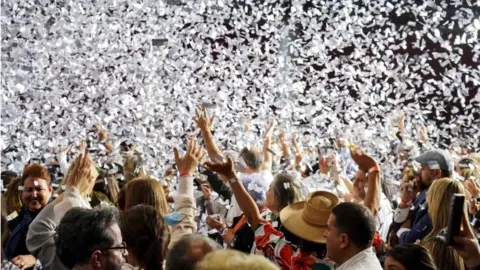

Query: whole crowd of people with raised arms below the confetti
[1,109,480,270]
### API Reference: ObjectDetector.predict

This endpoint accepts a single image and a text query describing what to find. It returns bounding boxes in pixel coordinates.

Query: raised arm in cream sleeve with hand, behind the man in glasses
[27,143,98,270]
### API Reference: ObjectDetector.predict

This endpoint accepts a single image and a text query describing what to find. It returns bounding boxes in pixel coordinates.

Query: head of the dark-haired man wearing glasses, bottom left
[55,207,128,270]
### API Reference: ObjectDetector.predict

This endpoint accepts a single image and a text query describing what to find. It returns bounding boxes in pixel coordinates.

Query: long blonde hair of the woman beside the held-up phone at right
[426,178,467,238]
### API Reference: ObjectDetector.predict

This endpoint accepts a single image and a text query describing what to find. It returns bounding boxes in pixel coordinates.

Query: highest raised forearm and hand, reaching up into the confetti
[193,108,223,162]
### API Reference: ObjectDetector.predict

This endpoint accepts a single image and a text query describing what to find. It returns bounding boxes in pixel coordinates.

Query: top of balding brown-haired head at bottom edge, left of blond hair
[166,234,221,270]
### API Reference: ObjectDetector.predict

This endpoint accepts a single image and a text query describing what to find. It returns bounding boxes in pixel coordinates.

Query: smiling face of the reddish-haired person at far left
[22,177,53,212]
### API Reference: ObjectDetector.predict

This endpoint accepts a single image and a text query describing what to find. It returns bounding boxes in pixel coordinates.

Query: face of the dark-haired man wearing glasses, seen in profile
[100,224,128,270]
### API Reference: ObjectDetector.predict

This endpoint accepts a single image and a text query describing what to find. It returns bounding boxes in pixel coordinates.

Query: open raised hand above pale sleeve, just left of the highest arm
[174,138,206,176]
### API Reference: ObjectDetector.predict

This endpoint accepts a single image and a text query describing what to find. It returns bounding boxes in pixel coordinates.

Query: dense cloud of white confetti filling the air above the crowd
[1,0,480,177]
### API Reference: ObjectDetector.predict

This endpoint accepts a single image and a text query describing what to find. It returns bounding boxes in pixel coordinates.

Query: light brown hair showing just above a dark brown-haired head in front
[125,176,169,215]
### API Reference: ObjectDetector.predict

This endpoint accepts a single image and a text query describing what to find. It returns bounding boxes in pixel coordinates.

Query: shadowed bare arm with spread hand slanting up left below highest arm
[204,157,262,229]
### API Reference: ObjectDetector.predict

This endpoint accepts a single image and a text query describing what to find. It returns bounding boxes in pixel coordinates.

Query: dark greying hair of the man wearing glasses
[55,207,119,269]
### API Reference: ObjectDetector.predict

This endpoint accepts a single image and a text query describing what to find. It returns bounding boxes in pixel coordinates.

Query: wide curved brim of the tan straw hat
[280,201,327,244]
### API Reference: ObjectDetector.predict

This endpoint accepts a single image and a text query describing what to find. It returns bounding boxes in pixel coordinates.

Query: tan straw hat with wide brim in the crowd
[280,191,340,244]
